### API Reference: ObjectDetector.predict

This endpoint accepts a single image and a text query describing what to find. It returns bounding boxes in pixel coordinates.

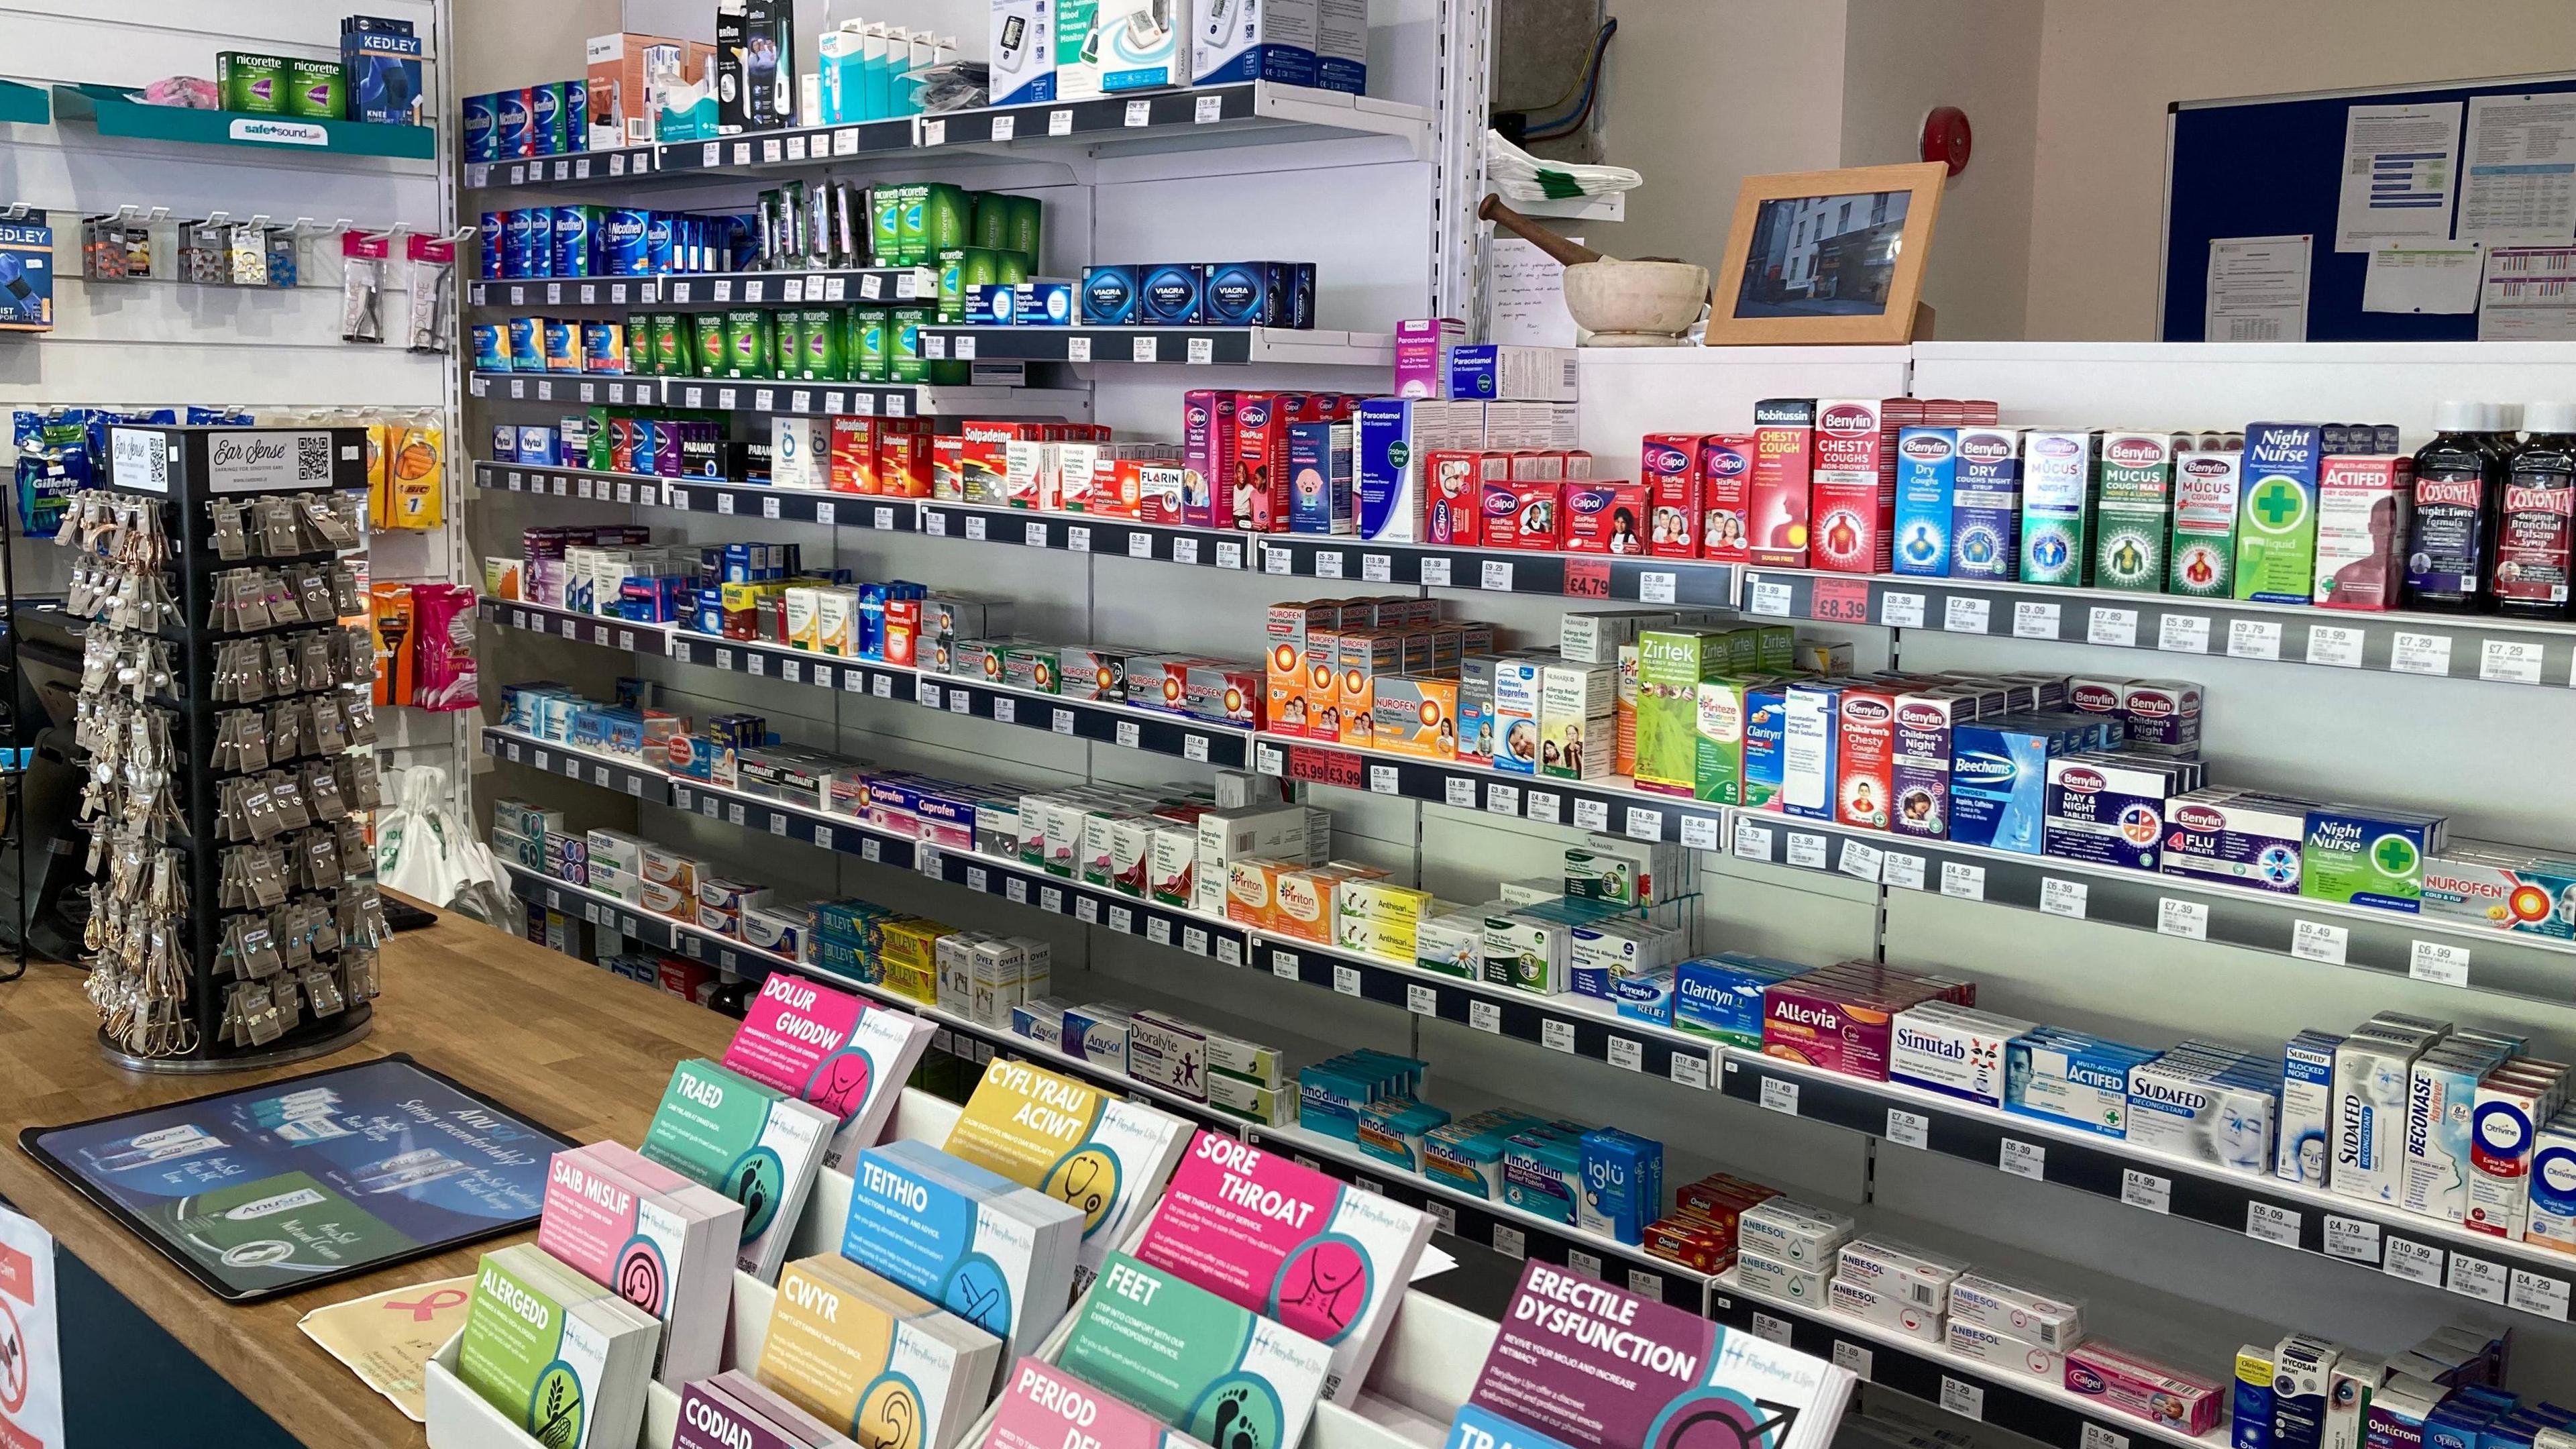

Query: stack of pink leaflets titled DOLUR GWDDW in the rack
[724,972,932,1168]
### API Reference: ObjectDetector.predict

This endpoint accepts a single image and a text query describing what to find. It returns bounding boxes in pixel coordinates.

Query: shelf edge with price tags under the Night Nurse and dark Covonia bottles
[1741,565,2576,686]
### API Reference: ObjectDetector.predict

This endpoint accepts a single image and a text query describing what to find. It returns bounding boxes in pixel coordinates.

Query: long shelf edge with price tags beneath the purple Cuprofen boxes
[482,724,1252,967]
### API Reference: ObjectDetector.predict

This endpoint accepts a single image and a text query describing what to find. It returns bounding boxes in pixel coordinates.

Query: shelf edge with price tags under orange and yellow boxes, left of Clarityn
[1252,933,1715,1091]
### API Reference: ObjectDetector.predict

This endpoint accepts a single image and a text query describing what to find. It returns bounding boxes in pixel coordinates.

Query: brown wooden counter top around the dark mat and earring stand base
[0,913,734,1446]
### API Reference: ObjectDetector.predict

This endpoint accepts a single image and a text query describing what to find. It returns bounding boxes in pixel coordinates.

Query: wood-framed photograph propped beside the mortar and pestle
[1708,160,1947,345]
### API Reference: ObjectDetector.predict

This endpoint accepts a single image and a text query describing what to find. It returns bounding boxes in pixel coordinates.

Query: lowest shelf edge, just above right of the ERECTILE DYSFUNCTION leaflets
[1708,1269,2229,1449]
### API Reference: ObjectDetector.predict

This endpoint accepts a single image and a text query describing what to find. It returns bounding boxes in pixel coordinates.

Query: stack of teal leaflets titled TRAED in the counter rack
[641,1060,840,1284]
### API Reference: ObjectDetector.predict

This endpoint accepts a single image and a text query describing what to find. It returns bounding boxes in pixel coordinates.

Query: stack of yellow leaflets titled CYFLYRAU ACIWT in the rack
[948,1046,1187,1273]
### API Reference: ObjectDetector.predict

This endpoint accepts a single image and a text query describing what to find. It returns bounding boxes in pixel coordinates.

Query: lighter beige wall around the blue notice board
[2029,0,2576,340]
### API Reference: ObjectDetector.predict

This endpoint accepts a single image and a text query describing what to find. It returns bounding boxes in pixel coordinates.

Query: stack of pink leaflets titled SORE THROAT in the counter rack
[1136,1132,1432,1403]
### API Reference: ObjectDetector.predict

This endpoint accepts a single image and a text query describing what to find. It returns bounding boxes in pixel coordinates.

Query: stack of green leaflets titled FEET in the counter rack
[1056,1253,1332,1449]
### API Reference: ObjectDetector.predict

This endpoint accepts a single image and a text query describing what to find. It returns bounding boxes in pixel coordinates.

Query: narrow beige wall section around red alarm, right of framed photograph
[1842,0,2043,340]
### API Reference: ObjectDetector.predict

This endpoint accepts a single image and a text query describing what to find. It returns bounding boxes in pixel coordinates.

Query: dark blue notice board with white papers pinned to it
[2161,74,2576,343]
